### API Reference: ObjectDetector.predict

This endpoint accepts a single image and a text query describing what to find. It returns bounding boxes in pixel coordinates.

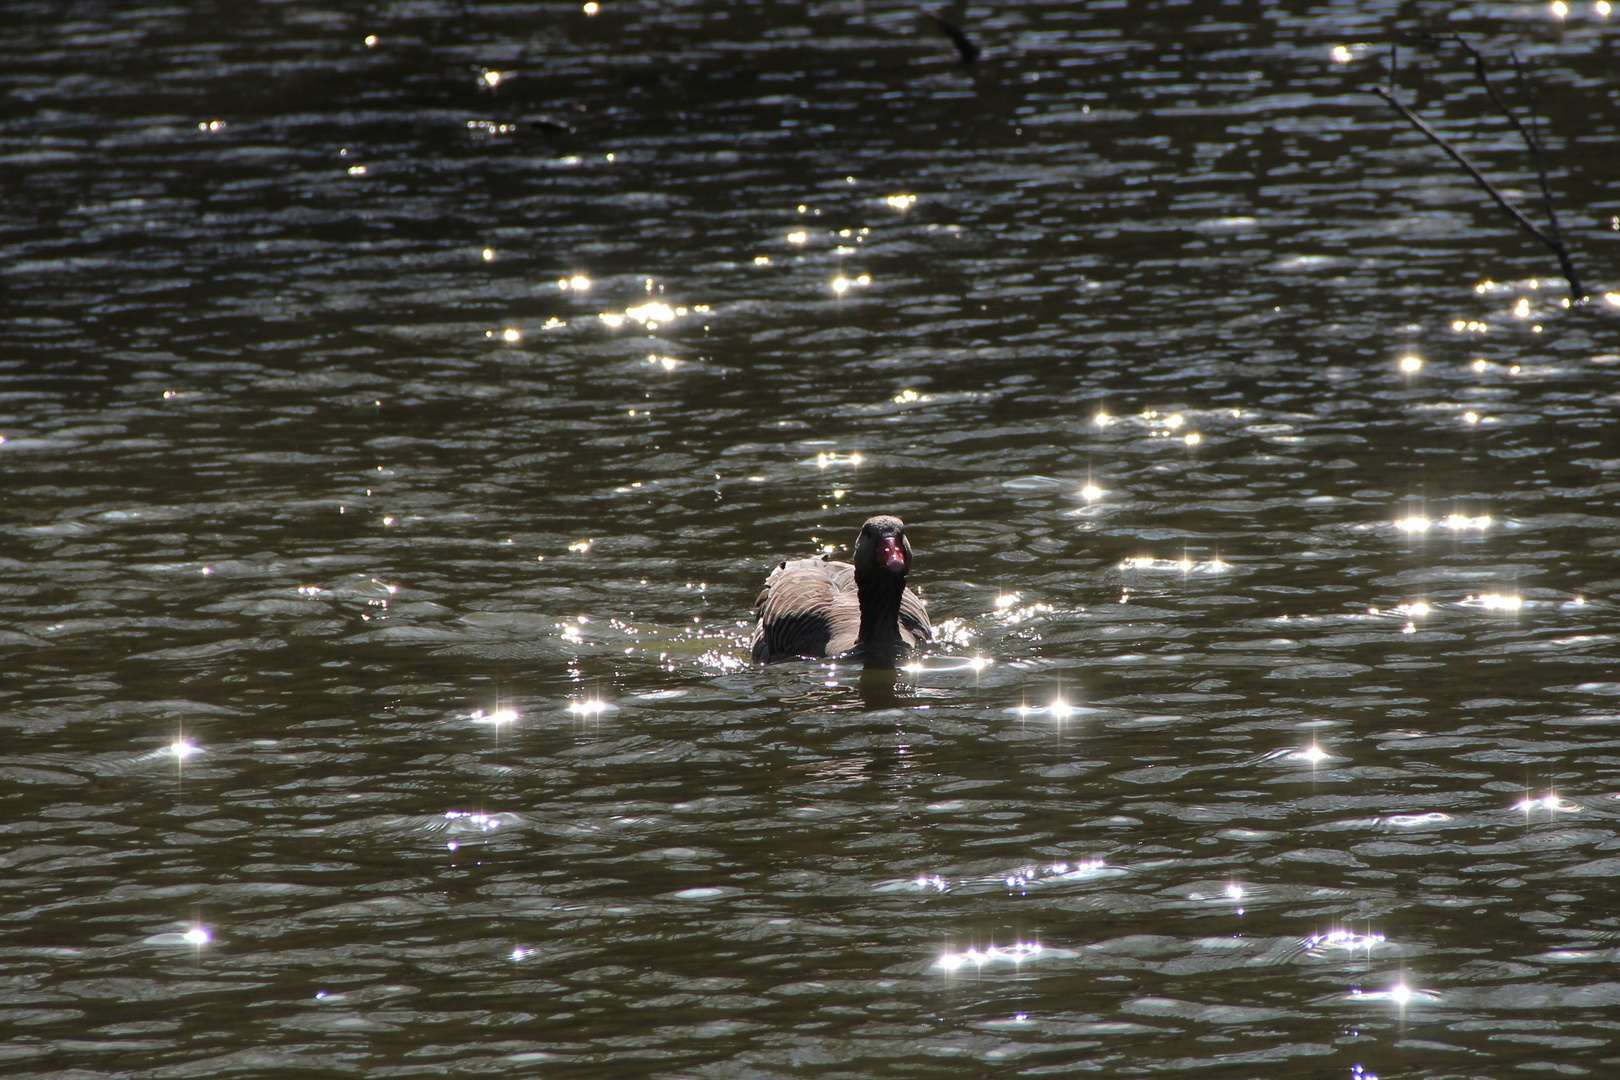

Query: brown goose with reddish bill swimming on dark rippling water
[753,515,933,667]
